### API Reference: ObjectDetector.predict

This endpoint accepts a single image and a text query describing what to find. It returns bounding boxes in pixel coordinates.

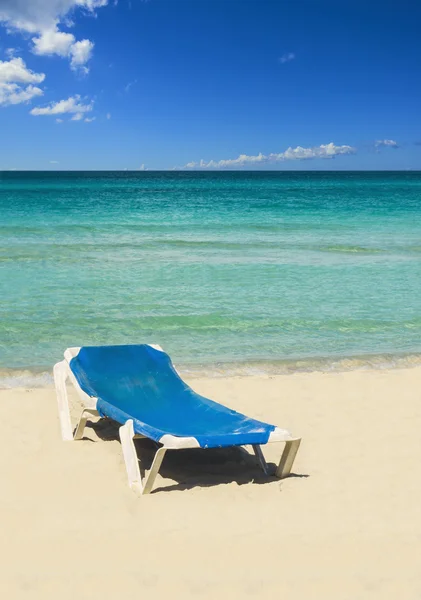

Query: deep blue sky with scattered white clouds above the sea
[0,0,421,170]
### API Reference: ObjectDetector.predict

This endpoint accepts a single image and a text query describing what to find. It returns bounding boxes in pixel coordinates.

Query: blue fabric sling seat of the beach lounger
[70,344,275,448]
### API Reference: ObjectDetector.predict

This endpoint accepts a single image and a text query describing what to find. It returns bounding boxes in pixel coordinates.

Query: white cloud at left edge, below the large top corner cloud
[0,58,45,106]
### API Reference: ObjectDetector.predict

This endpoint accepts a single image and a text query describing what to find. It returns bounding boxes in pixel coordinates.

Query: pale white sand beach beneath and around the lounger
[0,368,421,600]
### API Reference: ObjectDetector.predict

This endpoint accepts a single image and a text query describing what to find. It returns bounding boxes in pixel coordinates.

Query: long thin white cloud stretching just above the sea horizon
[184,142,356,169]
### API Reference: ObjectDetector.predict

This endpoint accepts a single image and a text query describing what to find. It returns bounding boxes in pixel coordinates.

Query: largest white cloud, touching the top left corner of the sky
[0,0,108,72]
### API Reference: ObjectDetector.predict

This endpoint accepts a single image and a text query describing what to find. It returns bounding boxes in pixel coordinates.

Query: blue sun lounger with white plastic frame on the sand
[54,344,301,494]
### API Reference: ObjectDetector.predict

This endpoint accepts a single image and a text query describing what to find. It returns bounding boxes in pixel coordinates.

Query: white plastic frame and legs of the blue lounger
[54,344,301,495]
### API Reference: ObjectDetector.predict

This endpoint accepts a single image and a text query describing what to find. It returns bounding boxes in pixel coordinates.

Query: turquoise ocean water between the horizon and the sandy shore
[0,172,421,386]
